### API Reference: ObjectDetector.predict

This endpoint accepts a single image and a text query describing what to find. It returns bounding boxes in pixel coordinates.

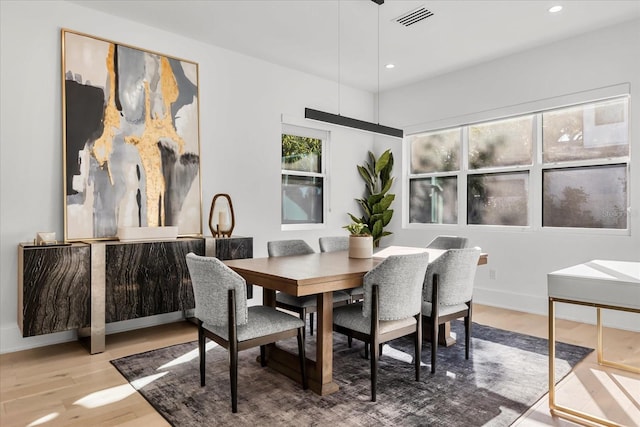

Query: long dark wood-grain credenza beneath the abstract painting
[18,236,253,354]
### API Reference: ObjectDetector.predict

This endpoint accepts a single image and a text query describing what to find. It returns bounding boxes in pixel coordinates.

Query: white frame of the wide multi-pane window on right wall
[402,91,632,235]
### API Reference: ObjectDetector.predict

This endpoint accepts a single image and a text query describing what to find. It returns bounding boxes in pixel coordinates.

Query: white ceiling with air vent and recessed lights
[69,0,640,93]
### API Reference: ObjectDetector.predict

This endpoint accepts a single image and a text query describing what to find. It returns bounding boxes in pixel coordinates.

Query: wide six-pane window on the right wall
[407,96,629,229]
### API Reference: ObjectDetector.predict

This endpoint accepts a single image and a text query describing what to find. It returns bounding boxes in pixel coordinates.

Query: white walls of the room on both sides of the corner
[0,0,640,353]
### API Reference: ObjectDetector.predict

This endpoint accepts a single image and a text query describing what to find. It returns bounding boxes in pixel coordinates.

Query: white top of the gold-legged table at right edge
[547,260,640,310]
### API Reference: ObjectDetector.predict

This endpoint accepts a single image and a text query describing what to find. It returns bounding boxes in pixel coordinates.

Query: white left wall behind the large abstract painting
[0,0,382,353]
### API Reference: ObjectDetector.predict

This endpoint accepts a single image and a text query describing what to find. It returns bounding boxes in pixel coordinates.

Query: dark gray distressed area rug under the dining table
[111,321,593,426]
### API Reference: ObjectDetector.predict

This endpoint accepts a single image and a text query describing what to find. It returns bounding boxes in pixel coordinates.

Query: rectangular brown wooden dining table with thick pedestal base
[224,246,487,395]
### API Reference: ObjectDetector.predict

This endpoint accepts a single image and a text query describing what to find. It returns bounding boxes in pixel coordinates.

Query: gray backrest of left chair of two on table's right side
[362,252,429,320]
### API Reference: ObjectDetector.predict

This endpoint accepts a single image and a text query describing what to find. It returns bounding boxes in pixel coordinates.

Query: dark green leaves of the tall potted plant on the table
[345,150,396,247]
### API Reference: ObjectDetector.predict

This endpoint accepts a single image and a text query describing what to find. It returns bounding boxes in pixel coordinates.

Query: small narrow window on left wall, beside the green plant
[281,125,328,225]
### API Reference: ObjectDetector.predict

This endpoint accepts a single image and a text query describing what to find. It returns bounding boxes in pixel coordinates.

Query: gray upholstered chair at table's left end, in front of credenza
[186,252,307,412]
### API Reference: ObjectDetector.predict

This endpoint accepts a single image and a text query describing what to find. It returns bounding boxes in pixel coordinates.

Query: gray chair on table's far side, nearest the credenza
[267,240,351,335]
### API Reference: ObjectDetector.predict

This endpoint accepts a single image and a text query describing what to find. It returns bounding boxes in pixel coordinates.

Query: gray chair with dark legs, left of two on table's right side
[333,253,429,402]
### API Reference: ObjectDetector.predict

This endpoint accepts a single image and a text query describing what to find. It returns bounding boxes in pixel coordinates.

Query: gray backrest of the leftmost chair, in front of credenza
[187,252,248,326]
